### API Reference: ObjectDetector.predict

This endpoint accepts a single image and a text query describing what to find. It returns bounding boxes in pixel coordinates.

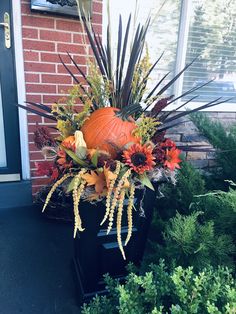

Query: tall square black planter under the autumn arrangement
[74,190,155,303]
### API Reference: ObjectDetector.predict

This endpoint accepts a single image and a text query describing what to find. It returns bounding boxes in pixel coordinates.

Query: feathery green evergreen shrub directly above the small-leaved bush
[143,212,235,270]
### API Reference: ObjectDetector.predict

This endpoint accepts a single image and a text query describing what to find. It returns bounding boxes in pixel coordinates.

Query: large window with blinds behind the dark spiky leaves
[104,0,236,111]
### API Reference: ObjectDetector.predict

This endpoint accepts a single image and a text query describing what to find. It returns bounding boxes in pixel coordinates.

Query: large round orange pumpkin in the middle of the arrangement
[81,107,140,158]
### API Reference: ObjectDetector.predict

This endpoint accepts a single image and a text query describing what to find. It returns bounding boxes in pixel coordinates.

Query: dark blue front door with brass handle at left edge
[0,0,21,184]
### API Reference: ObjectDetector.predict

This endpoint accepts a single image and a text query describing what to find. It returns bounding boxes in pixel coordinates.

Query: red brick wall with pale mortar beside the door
[21,0,102,193]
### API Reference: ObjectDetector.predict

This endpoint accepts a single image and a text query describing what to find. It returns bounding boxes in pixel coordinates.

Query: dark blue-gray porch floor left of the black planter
[0,207,79,314]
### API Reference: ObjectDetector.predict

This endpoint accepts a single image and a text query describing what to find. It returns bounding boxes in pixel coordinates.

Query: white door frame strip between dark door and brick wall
[12,0,30,180]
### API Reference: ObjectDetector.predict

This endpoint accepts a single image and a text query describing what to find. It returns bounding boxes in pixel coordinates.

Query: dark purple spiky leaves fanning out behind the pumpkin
[19,12,232,139]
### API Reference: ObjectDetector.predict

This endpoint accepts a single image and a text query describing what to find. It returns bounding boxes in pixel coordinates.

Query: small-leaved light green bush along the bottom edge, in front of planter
[82,261,236,314]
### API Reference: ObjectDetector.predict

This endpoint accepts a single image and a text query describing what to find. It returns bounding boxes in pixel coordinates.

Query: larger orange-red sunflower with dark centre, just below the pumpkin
[123,144,155,174]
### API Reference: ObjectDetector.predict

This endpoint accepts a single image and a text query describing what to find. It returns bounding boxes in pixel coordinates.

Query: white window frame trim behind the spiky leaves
[102,0,236,112]
